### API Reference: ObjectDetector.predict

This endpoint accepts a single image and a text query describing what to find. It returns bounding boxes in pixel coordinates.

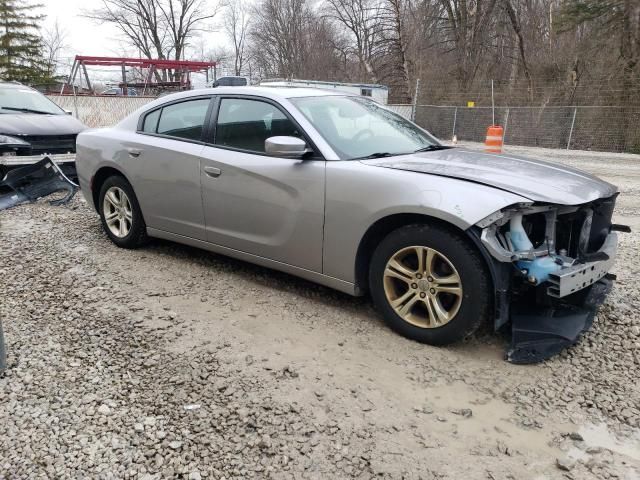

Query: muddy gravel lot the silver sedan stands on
[0,149,640,480]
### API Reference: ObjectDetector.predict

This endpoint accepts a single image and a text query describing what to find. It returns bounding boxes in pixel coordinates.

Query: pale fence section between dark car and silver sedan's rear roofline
[49,95,155,128]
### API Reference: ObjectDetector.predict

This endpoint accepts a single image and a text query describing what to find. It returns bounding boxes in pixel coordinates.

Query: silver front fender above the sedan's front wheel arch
[323,161,530,283]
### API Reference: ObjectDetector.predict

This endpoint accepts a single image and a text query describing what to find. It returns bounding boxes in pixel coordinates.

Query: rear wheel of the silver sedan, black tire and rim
[98,175,148,248]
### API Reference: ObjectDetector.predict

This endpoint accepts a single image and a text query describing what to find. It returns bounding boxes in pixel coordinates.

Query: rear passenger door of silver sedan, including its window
[128,96,213,240]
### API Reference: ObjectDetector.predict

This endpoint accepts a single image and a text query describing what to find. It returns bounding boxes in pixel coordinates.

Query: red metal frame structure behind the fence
[67,55,216,95]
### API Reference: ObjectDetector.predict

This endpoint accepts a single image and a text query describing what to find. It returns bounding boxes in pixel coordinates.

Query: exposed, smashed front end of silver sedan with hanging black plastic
[476,194,630,363]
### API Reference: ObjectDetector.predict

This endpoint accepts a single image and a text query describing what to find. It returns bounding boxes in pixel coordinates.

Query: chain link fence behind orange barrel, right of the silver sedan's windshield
[389,105,640,153]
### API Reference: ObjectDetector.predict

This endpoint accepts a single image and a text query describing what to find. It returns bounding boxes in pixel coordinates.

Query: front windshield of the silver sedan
[291,96,439,160]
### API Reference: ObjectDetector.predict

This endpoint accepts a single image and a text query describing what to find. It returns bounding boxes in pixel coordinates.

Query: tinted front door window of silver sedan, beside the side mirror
[215,98,301,152]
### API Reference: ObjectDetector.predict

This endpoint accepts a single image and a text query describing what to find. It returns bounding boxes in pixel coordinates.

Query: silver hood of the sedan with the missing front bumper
[362,148,618,205]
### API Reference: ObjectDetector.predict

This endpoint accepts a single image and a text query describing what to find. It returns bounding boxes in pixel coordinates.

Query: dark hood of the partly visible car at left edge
[0,113,87,136]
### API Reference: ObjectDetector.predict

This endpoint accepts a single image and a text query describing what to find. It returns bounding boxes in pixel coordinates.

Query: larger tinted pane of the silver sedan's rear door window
[157,98,210,140]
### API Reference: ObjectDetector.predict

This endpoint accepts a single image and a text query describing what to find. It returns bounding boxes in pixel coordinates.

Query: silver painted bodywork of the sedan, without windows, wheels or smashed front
[77,87,614,294]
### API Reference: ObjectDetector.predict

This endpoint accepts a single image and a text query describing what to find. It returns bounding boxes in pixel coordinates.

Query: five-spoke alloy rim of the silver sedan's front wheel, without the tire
[383,246,462,328]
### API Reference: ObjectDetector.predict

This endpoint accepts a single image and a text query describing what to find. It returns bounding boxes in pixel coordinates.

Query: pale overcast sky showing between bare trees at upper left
[38,0,225,84]
